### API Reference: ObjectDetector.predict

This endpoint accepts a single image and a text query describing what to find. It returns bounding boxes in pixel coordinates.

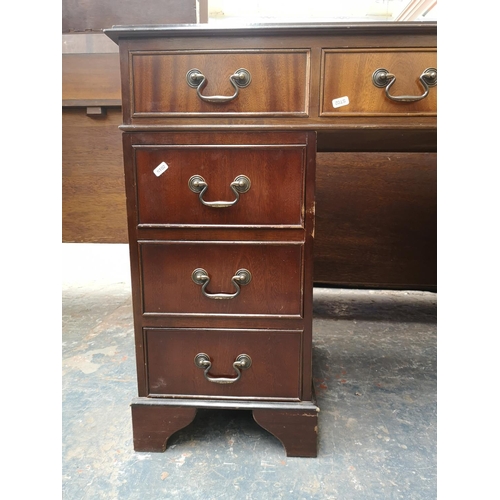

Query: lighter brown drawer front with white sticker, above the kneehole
[320,49,437,116]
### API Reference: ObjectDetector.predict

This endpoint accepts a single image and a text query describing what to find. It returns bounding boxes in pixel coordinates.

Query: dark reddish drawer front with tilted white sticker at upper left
[135,145,305,227]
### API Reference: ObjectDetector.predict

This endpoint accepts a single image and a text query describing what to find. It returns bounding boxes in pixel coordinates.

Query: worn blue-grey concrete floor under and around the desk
[62,244,437,500]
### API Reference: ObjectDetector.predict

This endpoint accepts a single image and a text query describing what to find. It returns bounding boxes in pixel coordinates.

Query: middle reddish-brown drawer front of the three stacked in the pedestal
[140,242,303,317]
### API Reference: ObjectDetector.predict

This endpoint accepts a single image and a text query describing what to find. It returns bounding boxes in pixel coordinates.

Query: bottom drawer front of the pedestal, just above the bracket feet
[145,329,302,399]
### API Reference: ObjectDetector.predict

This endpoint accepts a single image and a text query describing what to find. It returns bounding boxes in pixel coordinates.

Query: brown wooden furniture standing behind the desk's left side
[62,0,201,243]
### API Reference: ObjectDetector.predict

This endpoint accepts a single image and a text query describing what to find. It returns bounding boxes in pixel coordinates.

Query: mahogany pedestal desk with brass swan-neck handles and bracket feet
[105,23,437,457]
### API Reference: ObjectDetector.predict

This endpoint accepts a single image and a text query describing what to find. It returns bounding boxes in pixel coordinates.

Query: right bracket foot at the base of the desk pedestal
[253,409,318,458]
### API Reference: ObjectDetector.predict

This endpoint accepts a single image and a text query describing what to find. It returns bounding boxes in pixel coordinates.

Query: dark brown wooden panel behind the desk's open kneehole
[315,153,437,289]
